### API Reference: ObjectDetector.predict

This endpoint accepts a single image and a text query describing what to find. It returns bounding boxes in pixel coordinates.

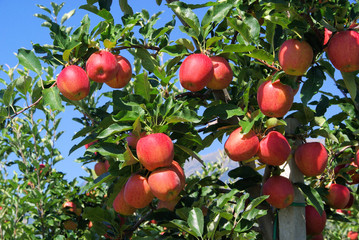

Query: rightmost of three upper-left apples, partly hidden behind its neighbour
[106,55,132,88]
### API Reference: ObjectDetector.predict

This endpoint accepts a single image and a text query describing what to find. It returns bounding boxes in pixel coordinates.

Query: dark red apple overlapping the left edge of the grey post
[262,176,294,208]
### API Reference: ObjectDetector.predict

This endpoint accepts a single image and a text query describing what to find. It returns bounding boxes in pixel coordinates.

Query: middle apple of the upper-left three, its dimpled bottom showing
[86,50,120,83]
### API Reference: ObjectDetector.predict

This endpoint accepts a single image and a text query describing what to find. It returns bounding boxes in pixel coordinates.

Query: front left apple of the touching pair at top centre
[179,53,214,92]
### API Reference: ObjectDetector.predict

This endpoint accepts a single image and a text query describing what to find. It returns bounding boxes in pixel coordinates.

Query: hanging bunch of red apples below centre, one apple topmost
[113,133,186,215]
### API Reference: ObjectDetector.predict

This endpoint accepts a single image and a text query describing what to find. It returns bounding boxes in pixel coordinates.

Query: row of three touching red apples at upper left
[56,50,132,101]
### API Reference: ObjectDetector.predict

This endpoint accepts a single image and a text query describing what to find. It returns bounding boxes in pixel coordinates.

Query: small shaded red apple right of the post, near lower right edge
[327,183,350,209]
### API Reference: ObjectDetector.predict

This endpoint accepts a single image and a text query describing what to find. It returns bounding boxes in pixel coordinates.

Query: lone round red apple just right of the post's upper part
[294,142,328,177]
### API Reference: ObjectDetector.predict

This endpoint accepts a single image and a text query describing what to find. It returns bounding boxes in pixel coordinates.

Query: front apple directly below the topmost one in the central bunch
[148,167,182,201]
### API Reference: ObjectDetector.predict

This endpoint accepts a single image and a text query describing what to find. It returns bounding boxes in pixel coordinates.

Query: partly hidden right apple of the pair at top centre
[207,56,233,90]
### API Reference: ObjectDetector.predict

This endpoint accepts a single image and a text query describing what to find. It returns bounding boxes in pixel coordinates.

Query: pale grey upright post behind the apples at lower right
[278,118,306,240]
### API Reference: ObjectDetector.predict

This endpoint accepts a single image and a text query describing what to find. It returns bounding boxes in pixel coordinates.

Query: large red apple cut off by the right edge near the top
[327,30,359,72]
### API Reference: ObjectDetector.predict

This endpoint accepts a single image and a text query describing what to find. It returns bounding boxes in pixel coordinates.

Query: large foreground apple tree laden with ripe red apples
[1,0,359,239]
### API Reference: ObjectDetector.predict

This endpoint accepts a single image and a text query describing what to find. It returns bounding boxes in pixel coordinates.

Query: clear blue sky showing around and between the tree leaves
[0,0,348,180]
